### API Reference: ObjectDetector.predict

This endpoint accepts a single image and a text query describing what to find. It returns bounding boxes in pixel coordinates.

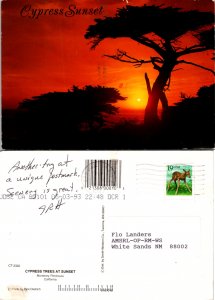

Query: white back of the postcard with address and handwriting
[0,151,214,300]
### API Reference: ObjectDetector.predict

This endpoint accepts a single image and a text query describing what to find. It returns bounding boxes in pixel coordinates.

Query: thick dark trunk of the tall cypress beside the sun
[144,61,175,126]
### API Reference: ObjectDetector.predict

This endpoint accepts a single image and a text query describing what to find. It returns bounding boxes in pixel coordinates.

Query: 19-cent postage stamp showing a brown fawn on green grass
[166,165,192,196]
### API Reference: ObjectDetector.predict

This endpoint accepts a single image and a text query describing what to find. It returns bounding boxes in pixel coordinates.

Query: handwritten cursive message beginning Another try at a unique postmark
[0,154,81,215]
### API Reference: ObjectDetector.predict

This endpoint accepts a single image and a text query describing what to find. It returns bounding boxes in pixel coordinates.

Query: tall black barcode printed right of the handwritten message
[85,159,122,188]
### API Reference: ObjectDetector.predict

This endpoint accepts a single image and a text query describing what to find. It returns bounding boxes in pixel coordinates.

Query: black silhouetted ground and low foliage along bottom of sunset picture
[2,85,215,150]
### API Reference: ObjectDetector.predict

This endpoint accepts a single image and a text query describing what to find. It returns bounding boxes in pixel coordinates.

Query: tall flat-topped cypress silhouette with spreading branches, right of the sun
[85,5,215,125]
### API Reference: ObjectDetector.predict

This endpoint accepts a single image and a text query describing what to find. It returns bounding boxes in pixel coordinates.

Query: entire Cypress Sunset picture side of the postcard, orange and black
[2,0,214,150]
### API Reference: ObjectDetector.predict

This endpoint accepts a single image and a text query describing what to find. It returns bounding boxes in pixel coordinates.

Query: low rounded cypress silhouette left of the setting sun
[16,85,126,148]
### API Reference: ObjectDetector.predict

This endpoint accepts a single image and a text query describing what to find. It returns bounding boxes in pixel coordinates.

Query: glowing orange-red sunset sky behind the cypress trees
[2,0,214,109]
